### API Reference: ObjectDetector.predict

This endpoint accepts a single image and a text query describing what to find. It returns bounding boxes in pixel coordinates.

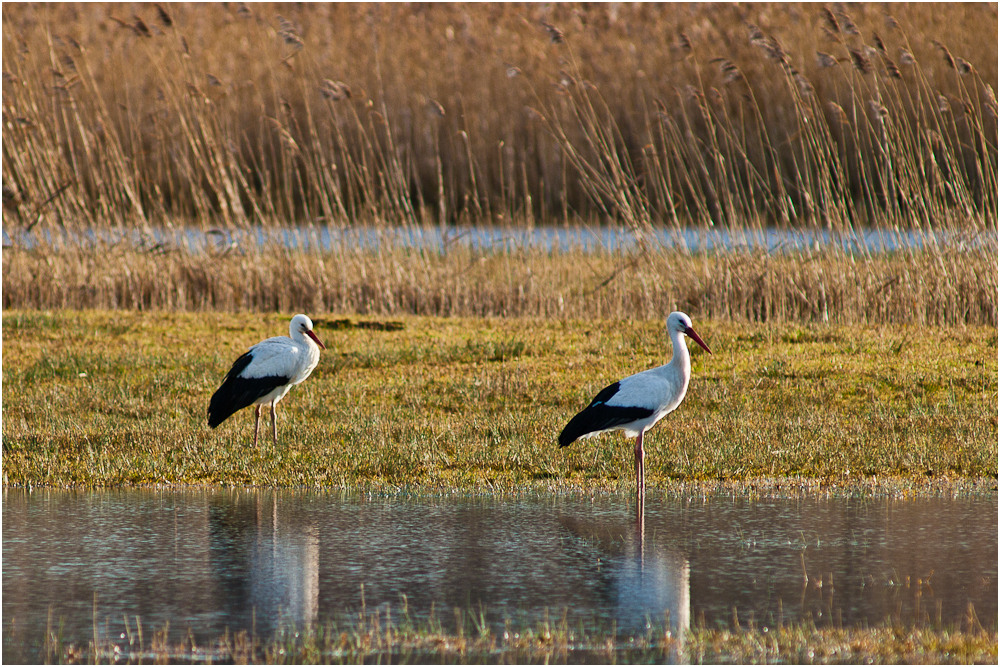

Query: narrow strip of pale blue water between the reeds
[3,224,997,254]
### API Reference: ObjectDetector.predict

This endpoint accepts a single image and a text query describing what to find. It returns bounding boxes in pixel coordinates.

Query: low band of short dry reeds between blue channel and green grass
[3,247,997,325]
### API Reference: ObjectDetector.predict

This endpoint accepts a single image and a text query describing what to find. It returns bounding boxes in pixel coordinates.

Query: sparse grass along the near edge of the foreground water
[19,610,997,664]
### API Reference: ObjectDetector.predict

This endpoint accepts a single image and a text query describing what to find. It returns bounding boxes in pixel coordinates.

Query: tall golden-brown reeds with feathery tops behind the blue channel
[3,3,997,229]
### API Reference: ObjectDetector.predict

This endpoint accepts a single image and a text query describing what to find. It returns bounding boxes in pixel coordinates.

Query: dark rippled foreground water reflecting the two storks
[2,489,997,662]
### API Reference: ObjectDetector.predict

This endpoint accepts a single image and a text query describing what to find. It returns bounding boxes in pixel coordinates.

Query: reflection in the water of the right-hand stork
[560,502,691,634]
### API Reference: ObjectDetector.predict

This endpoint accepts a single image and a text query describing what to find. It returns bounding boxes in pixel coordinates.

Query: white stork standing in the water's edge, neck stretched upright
[559,312,712,512]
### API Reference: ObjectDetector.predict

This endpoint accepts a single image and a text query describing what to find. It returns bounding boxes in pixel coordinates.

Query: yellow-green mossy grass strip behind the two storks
[3,311,997,492]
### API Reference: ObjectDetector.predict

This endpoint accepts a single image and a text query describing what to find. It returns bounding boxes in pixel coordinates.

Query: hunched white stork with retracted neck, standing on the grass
[208,315,326,447]
